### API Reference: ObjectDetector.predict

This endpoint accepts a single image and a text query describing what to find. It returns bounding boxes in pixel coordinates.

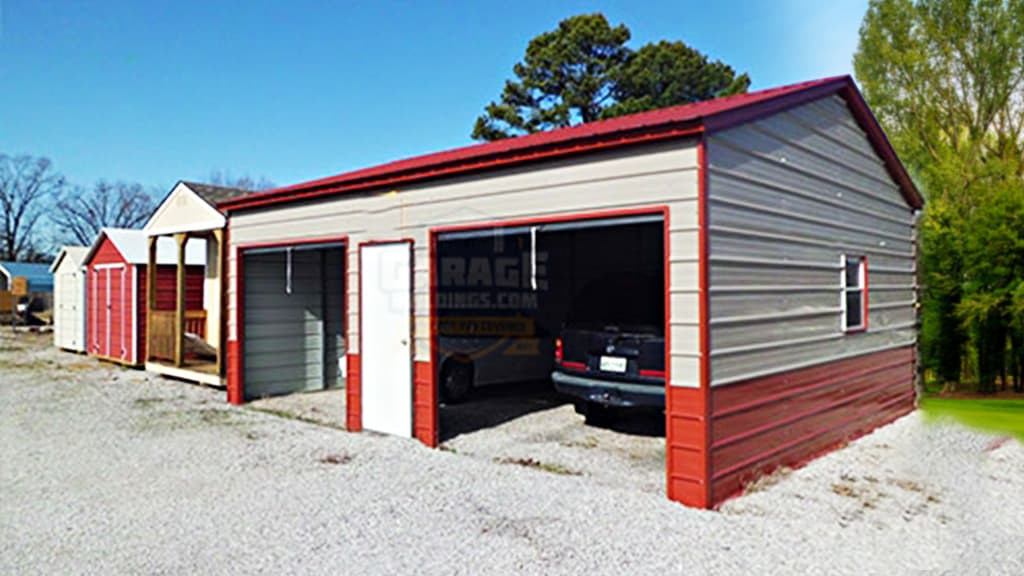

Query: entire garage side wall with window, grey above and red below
[707,97,916,502]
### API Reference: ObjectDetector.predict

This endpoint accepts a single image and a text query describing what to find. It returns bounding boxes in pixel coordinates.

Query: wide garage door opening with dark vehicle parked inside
[434,212,666,489]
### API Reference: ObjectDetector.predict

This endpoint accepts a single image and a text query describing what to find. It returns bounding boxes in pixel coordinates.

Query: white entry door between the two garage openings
[359,242,413,438]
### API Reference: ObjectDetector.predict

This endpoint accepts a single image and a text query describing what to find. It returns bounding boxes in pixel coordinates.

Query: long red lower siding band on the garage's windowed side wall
[711,346,914,505]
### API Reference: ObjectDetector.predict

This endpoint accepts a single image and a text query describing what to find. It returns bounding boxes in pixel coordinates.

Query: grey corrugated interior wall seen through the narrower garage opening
[243,250,326,399]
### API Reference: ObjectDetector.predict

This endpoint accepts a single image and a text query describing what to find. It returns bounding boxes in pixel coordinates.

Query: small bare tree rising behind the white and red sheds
[52,180,156,246]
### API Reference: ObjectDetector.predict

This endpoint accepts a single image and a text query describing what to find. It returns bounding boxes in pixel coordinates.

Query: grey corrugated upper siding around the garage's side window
[708,97,915,384]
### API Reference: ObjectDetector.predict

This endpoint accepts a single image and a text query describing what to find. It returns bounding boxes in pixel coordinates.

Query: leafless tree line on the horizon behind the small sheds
[0,153,273,261]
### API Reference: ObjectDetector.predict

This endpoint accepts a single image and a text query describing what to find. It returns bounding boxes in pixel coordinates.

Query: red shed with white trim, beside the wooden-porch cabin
[84,229,206,366]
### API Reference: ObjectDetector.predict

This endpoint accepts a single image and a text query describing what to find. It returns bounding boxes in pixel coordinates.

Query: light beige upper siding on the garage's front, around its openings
[228,139,699,386]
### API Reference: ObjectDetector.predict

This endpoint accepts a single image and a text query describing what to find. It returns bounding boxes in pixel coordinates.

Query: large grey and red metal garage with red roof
[218,77,923,507]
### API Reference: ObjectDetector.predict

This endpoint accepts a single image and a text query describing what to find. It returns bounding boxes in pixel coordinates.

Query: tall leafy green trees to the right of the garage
[854,0,1024,392]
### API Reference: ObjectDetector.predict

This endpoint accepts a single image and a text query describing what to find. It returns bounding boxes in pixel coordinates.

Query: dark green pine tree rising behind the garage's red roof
[472,13,750,140]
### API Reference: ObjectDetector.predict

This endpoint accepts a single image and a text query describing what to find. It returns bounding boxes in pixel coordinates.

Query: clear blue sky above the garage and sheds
[0,0,866,190]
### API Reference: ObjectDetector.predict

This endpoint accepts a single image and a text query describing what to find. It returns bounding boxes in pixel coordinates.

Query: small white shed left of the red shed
[50,246,89,352]
